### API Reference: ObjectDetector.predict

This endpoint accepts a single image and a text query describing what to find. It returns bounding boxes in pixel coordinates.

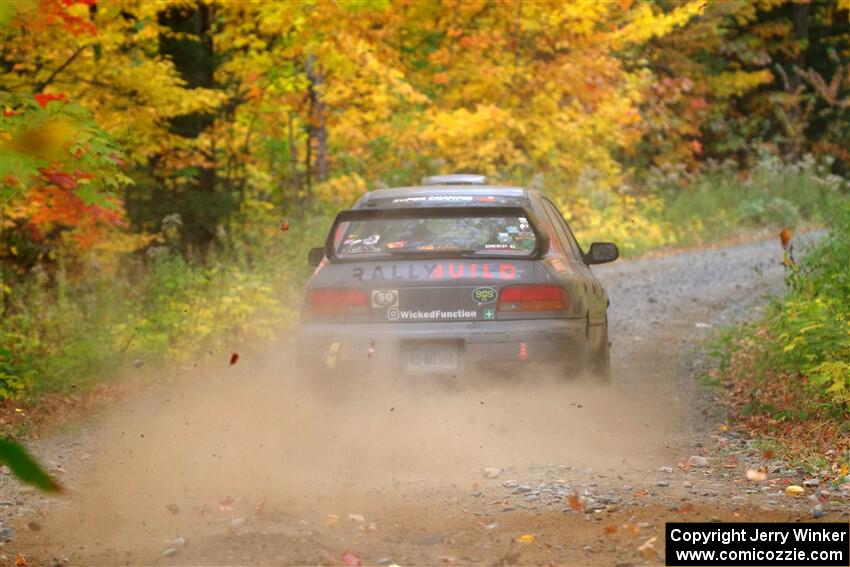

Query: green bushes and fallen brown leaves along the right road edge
[711,201,850,479]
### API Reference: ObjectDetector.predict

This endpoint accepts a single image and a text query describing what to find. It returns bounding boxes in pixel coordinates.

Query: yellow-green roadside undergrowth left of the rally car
[0,212,326,404]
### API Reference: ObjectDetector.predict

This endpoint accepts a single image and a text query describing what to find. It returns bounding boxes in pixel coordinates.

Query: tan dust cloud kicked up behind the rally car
[38,340,675,550]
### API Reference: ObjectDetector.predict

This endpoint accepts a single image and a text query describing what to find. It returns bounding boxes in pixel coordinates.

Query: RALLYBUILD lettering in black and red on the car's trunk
[352,262,522,282]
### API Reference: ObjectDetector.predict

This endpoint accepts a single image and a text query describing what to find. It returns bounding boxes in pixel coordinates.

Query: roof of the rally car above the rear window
[354,184,532,209]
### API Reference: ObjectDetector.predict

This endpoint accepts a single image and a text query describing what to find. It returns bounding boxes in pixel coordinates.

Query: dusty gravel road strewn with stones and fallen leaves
[0,233,850,566]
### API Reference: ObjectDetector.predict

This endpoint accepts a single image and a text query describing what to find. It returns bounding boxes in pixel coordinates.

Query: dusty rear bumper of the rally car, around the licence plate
[297,319,586,373]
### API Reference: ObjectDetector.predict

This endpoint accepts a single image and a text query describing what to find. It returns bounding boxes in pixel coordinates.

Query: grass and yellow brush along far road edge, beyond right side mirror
[560,155,848,257]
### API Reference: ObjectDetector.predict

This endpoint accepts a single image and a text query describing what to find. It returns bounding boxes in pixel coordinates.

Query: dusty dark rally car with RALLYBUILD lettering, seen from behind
[298,175,619,380]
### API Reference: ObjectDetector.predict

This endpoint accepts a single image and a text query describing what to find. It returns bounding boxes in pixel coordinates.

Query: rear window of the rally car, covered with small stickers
[334,215,537,258]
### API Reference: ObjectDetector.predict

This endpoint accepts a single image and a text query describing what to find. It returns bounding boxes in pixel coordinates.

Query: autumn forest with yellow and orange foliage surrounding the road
[0,0,850,464]
